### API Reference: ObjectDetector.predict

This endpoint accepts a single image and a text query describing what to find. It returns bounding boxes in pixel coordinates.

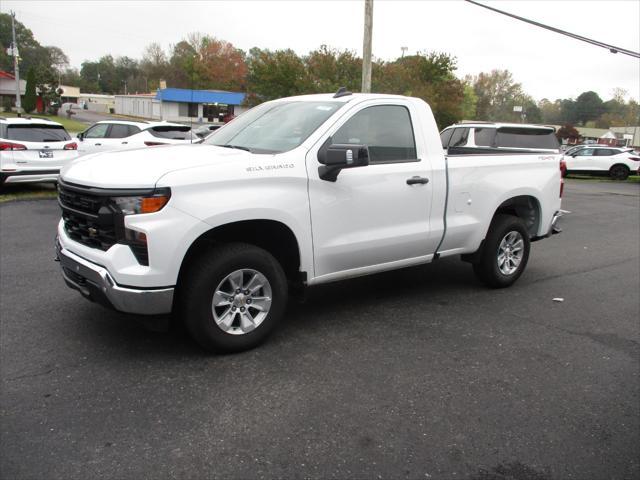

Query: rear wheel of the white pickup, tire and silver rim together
[473,215,531,288]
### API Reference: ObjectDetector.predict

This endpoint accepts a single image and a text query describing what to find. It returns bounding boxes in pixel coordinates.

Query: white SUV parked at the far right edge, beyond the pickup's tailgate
[564,145,640,180]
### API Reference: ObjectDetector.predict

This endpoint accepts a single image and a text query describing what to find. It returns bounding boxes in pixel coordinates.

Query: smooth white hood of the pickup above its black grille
[60,145,254,188]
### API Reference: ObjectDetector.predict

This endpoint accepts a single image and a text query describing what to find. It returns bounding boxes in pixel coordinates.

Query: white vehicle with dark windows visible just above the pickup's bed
[440,122,560,153]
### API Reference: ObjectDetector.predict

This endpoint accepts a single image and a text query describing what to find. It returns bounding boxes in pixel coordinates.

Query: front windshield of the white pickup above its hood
[205,101,344,153]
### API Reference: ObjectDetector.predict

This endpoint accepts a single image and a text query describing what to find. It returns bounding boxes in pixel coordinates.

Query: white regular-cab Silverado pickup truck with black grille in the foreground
[56,89,562,351]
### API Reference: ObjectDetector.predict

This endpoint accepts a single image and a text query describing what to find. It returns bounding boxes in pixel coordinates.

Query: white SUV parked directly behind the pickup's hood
[77,120,202,155]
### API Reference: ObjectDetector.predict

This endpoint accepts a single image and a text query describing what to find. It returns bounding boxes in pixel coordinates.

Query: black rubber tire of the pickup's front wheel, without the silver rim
[178,243,288,353]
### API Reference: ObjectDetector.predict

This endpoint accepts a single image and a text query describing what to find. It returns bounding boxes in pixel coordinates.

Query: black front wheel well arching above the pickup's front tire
[178,220,301,284]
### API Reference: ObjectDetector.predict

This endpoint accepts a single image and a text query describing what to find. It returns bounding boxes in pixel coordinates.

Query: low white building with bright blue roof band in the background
[115,88,247,123]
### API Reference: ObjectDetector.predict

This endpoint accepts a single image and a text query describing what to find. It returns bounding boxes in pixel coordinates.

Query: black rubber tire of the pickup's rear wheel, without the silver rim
[473,214,531,288]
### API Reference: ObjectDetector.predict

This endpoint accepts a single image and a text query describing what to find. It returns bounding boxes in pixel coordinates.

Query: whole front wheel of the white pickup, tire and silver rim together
[180,243,288,352]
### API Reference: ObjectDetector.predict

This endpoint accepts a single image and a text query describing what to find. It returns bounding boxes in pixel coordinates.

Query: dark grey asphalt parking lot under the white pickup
[0,181,640,480]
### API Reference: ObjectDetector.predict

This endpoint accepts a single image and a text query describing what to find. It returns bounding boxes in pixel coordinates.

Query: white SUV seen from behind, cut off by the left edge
[0,117,78,185]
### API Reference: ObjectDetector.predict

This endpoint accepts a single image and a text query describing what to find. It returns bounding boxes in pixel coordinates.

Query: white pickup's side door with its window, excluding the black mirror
[306,99,441,279]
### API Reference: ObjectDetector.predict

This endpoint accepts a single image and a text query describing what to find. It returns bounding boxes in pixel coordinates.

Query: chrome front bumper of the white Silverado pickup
[56,239,174,315]
